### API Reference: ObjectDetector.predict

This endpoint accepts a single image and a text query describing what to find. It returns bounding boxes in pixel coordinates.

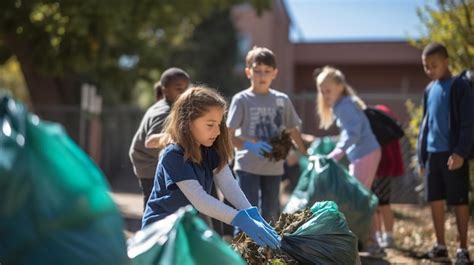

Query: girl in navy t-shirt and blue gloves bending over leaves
[142,87,280,248]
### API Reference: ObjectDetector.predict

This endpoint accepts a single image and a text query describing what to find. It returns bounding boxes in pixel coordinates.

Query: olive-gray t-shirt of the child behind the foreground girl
[129,99,171,179]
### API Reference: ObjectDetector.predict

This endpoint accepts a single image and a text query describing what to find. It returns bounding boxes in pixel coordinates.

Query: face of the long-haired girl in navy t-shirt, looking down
[191,107,224,147]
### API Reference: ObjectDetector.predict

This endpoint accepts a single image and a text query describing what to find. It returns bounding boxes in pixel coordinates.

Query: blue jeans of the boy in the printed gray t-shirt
[236,170,281,224]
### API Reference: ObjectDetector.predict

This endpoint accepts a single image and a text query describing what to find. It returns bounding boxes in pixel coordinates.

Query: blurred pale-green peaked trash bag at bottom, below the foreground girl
[128,206,245,265]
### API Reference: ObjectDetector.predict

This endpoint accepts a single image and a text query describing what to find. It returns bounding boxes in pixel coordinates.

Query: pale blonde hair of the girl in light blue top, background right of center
[313,66,366,129]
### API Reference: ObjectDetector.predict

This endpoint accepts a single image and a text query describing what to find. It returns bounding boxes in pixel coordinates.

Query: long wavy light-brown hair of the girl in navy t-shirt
[159,85,233,171]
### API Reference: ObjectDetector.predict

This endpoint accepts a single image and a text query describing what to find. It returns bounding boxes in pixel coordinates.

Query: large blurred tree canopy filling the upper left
[0,0,270,105]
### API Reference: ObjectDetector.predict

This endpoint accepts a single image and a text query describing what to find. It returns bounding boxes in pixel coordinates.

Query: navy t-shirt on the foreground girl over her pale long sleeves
[142,144,219,228]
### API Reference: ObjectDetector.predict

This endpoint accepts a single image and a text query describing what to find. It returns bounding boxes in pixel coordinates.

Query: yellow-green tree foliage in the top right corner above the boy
[413,0,474,73]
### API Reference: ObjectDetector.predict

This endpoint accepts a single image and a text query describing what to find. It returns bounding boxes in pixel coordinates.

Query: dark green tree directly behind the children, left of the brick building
[169,9,248,97]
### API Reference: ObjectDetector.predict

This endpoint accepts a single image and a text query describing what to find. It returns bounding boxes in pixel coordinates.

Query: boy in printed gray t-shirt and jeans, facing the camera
[227,47,307,222]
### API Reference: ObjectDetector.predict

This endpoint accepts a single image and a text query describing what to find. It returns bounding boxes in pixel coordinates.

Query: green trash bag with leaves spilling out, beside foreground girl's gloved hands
[281,201,359,265]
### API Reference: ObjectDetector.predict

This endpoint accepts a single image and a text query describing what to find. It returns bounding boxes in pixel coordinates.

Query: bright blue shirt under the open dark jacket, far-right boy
[426,78,453,153]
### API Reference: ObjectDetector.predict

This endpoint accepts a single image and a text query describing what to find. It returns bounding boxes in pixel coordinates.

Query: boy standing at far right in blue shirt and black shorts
[417,43,474,264]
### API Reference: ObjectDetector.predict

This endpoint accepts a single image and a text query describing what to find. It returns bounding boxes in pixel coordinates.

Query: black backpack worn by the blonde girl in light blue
[364,107,405,146]
